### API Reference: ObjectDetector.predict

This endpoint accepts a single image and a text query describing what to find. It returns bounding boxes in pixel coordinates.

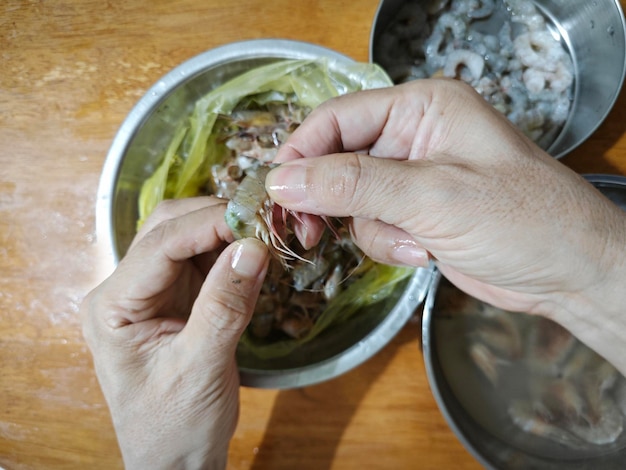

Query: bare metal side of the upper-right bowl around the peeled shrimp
[370,0,626,158]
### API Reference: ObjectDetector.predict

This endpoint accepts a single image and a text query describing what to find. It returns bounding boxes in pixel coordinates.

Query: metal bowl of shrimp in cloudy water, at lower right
[422,175,626,470]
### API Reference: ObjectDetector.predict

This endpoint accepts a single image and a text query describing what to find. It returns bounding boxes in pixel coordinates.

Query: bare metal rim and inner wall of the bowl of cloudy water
[422,175,626,470]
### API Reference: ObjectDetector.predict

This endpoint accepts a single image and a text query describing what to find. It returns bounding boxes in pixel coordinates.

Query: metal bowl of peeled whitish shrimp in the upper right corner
[370,0,626,158]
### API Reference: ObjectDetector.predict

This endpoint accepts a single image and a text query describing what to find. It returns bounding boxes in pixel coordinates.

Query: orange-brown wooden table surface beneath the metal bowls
[0,0,626,470]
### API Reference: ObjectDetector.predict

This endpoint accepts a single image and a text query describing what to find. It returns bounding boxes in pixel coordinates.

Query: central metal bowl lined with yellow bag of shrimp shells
[96,39,432,388]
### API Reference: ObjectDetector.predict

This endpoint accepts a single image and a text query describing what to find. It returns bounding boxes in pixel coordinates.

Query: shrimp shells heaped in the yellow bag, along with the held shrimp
[206,103,371,340]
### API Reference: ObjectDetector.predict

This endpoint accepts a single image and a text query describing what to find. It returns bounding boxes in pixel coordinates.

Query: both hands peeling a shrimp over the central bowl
[82,80,626,468]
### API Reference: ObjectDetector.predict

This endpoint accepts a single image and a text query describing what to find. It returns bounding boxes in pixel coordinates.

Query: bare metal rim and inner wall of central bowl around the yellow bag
[96,40,431,388]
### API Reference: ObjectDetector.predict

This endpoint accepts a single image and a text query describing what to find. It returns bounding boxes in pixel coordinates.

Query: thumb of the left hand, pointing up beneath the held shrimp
[179,238,269,361]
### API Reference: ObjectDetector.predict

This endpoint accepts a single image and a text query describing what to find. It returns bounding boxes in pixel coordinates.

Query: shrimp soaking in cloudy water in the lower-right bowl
[441,280,626,451]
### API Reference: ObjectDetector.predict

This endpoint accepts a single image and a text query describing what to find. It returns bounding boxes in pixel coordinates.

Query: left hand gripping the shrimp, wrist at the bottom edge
[81,198,268,469]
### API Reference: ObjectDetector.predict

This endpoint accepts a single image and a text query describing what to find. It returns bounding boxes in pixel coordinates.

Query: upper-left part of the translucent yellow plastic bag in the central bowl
[139,58,391,224]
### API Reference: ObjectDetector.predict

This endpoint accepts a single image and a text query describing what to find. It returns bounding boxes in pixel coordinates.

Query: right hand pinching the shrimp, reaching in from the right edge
[266,80,626,370]
